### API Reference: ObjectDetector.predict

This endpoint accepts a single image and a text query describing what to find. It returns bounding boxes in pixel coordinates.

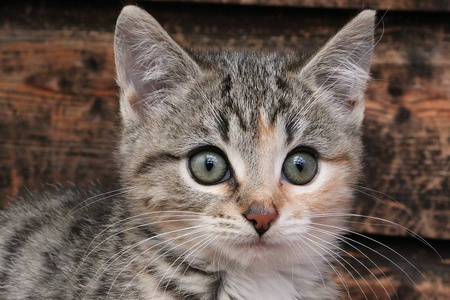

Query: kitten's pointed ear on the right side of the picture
[300,10,376,125]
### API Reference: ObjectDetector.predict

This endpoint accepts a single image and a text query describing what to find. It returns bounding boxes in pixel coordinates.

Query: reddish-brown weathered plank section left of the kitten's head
[0,31,117,209]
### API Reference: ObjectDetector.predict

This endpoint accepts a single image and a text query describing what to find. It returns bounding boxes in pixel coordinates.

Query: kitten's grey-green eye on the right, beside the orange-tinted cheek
[282,150,317,185]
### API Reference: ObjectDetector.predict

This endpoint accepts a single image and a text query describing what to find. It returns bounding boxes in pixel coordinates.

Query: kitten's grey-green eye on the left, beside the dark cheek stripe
[189,150,230,185]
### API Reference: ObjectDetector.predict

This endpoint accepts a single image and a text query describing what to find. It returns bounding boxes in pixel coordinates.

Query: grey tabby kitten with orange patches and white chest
[0,6,375,300]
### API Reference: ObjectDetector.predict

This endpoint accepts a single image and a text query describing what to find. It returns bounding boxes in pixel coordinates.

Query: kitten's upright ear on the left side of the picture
[114,5,201,125]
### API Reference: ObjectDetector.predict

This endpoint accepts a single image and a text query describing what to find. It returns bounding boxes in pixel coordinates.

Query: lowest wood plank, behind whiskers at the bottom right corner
[340,235,450,300]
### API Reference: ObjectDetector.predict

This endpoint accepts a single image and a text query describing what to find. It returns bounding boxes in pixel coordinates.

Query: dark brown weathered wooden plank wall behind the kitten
[0,0,450,299]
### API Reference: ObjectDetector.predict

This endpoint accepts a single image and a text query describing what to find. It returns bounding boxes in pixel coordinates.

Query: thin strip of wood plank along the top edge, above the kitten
[145,0,450,11]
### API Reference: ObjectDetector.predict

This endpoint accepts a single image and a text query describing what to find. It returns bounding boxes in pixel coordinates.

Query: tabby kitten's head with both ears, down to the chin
[115,6,375,265]
